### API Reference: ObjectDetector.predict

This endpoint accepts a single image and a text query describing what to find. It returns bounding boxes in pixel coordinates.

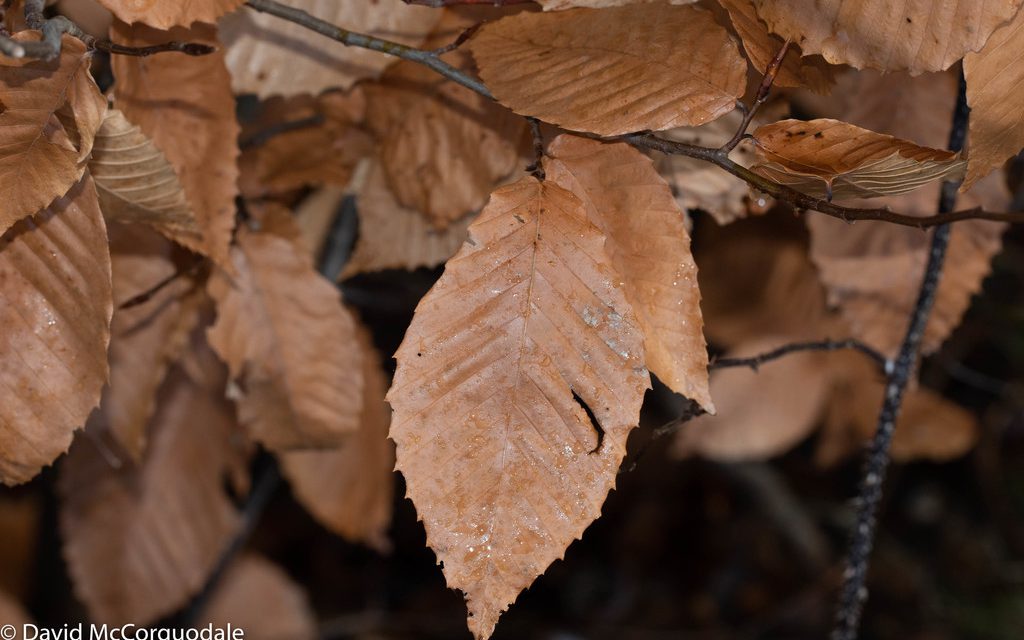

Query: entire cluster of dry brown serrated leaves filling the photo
[0,0,1024,638]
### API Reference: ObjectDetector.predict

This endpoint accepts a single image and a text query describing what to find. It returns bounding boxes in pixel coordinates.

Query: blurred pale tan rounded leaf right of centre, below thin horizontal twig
[673,337,829,461]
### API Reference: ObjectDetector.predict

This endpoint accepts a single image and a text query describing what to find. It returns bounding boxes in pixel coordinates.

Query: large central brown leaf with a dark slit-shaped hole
[388,177,649,638]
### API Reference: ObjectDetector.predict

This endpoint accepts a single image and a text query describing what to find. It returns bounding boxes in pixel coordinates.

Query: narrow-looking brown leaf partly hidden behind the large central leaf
[544,134,715,413]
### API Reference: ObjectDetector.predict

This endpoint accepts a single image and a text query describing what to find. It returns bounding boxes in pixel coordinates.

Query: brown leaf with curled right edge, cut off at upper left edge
[0,32,106,233]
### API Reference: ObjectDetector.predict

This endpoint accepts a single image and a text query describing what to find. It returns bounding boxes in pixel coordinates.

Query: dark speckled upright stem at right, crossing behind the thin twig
[831,73,970,640]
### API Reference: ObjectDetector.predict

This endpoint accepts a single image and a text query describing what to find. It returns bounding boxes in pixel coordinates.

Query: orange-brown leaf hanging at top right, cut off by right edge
[961,10,1024,190]
